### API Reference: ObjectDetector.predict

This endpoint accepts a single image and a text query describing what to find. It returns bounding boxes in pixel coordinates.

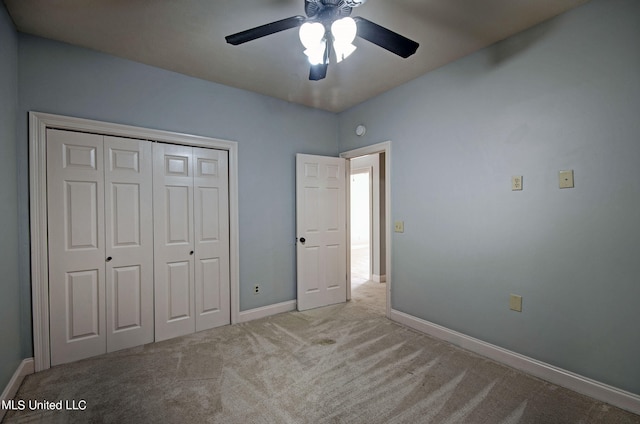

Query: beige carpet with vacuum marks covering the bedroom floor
[5,282,640,424]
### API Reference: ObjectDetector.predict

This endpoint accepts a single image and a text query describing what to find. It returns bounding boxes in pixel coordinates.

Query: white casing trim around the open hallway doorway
[340,141,393,318]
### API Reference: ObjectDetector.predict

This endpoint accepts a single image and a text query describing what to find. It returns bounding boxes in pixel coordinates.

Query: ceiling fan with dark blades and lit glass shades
[225,0,419,81]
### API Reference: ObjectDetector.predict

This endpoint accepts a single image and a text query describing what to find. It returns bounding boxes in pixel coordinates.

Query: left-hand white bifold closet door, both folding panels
[47,129,154,365]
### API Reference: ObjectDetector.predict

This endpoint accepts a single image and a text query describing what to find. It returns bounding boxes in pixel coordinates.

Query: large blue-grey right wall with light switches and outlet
[340,0,640,394]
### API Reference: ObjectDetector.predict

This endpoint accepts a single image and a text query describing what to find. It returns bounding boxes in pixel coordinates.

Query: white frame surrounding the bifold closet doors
[29,112,240,372]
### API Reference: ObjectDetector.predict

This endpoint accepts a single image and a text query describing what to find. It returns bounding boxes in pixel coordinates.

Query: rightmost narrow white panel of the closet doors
[193,148,231,331]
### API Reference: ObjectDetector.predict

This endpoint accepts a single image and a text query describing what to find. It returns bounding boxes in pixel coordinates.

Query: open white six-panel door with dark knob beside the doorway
[296,154,347,311]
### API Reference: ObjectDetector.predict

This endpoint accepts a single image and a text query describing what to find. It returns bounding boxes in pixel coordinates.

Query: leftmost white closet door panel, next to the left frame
[47,129,107,365]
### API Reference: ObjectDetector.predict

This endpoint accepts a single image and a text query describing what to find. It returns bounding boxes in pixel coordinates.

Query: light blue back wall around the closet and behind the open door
[14,34,338,356]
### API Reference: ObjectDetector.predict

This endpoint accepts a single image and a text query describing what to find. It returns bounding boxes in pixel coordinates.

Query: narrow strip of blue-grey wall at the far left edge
[0,5,22,391]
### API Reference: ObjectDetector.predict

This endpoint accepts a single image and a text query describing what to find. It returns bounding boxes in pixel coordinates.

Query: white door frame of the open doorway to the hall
[340,141,393,318]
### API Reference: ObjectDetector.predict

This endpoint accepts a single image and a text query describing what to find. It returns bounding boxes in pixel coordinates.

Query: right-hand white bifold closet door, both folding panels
[153,143,231,341]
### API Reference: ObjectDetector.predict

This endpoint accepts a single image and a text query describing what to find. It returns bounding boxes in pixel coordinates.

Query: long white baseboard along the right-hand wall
[390,309,640,415]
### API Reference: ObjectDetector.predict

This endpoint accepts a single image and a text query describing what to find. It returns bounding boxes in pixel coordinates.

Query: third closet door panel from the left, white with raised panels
[153,143,195,341]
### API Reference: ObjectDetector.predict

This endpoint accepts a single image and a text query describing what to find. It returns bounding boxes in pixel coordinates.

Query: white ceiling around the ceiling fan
[4,0,588,112]
